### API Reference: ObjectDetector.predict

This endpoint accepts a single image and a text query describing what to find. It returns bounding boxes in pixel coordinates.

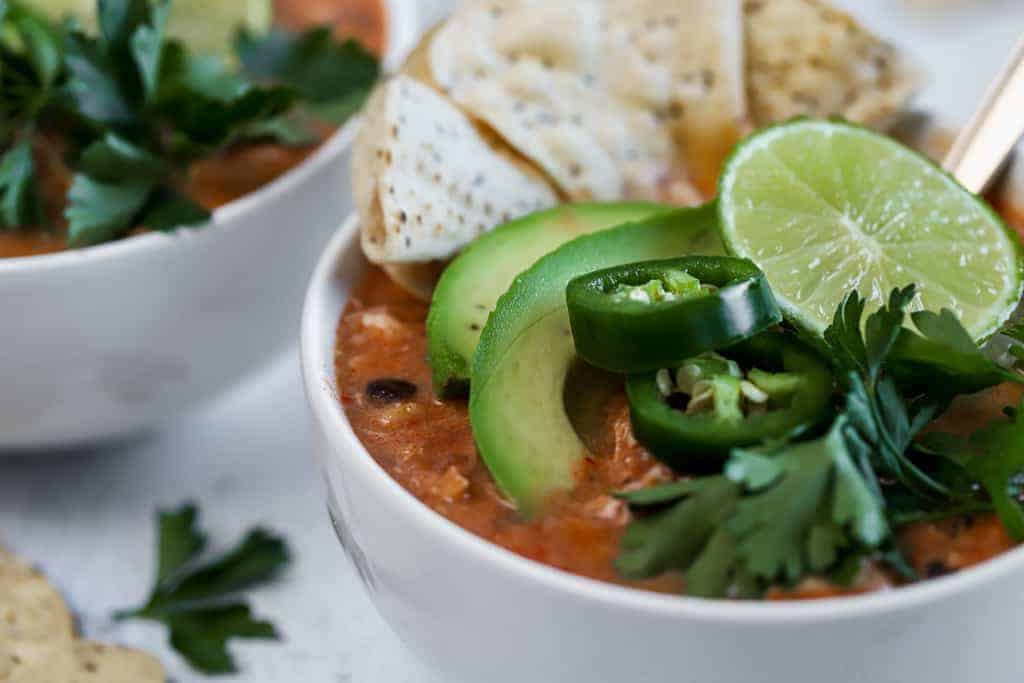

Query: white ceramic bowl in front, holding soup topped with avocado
[302,219,1024,683]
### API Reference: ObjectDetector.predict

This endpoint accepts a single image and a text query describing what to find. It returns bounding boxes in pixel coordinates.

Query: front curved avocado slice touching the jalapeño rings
[469,205,723,516]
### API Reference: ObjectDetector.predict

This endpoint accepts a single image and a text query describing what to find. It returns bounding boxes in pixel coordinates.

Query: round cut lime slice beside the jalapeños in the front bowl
[719,121,1024,339]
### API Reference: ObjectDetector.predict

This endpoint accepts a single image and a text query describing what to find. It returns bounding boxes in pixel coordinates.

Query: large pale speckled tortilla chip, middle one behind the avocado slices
[430,0,745,201]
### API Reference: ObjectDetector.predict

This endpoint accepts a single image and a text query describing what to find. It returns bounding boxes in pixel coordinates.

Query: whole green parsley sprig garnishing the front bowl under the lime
[617,286,1024,597]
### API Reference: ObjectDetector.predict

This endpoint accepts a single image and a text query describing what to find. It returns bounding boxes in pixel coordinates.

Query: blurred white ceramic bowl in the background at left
[0,0,418,453]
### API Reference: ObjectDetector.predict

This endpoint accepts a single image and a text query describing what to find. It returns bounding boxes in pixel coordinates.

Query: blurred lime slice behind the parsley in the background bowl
[28,0,273,60]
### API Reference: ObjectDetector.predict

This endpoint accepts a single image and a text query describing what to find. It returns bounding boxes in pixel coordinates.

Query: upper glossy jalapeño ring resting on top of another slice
[565,256,782,374]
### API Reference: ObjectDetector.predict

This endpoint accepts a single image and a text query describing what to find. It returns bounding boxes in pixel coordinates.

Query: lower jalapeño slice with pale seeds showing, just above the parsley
[626,332,833,471]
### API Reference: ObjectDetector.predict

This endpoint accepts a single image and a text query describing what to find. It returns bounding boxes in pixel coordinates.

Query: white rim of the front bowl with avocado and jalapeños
[300,214,1024,625]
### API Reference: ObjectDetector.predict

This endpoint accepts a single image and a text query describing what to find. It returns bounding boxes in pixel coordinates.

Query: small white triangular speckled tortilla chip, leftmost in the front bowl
[352,76,558,263]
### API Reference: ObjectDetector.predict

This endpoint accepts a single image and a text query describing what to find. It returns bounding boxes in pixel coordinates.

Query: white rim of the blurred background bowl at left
[0,0,420,278]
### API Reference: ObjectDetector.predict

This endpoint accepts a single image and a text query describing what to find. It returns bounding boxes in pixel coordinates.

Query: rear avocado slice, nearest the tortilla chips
[427,202,671,398]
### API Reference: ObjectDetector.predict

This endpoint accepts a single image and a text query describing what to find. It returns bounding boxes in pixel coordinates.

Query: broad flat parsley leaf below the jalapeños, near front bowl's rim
[616,417,890,597]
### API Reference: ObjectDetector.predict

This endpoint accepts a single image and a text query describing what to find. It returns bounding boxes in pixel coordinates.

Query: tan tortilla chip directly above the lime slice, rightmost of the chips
[744,0,920,128]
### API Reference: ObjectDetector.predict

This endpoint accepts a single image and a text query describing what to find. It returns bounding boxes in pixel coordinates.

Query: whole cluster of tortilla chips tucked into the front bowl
[352,0,919,299]
